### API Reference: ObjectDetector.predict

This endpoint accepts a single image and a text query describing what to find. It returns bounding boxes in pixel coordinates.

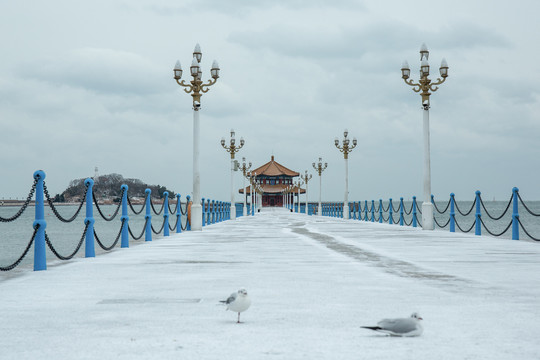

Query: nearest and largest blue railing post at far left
[32,170,47,271]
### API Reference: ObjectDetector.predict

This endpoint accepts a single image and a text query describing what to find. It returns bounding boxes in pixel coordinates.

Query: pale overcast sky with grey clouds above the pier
[0,0,540,201]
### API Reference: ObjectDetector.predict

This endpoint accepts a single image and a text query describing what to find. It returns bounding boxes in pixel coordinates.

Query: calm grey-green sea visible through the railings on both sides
[0,201,540,280]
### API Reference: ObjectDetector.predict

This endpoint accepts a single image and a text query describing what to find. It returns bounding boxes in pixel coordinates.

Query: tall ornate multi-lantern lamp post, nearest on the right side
[401,44,448,230]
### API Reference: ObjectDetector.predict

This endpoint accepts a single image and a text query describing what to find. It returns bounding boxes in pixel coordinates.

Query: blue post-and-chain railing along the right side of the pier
[322,188,540,241]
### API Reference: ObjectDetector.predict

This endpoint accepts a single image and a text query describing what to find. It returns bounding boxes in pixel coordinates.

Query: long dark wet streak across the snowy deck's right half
[292,227,480,289]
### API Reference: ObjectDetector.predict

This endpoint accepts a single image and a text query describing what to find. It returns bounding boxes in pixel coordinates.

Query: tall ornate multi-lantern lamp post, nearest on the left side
[173,44,219,231]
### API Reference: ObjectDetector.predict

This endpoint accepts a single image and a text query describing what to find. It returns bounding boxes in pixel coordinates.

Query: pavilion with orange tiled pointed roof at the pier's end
[238,155,306,206]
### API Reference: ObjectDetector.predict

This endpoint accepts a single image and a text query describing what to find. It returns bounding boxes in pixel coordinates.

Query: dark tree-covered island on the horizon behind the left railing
[54,174,176,204]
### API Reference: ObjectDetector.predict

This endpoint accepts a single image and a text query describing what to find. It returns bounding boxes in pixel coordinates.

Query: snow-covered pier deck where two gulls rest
[0,209,540,360]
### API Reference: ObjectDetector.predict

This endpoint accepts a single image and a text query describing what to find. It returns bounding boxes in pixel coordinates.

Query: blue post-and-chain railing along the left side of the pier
[0,170,230,271]
